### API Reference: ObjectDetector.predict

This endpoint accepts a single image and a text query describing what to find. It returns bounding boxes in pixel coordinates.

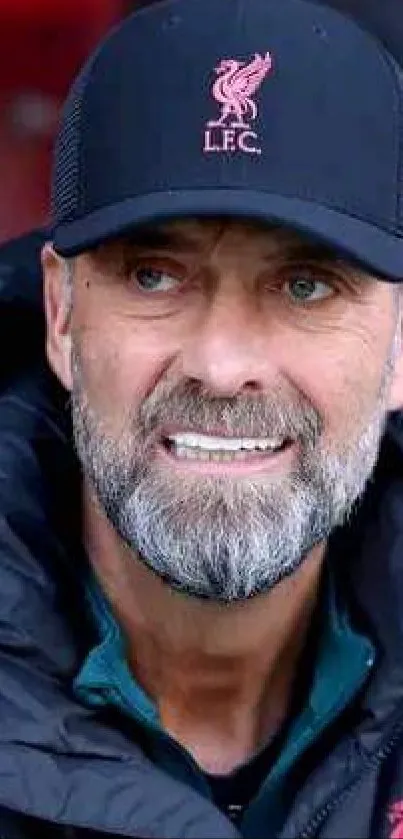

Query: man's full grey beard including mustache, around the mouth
[72,350,392,602]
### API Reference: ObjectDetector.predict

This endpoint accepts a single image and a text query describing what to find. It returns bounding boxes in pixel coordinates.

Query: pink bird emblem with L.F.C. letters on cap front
[204,52,273,154]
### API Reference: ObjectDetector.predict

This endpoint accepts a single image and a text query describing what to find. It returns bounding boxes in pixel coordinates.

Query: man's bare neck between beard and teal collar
[84,482,325,774]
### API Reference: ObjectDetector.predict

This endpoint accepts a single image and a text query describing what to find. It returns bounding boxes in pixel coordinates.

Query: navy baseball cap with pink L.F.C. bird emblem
[53,0,403,281]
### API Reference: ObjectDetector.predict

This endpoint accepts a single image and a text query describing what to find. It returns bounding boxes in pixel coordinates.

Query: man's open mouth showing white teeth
[164,432,292,463]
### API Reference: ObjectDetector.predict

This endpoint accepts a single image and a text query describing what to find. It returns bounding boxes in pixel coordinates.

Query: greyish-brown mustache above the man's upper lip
[137,381,323,446]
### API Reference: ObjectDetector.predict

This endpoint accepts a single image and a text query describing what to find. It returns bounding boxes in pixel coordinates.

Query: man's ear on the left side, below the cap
[42,243,72,391]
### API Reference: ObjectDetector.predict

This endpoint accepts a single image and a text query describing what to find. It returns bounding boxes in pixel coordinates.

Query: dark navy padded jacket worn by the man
[0,234,403,839]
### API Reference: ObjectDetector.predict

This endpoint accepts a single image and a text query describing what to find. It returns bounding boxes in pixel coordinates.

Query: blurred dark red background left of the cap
[0,0,135,241]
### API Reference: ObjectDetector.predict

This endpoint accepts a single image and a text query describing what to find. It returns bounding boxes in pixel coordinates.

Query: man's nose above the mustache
[182,293,276,397]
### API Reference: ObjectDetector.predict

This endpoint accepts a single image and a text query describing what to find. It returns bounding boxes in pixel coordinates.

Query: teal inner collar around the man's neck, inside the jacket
[74,563,375,836]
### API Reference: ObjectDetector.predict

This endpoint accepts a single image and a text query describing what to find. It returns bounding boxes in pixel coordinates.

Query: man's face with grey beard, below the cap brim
[45,220,399,601]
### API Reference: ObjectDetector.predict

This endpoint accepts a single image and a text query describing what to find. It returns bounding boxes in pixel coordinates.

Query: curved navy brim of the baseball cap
[54,189,403,282]
